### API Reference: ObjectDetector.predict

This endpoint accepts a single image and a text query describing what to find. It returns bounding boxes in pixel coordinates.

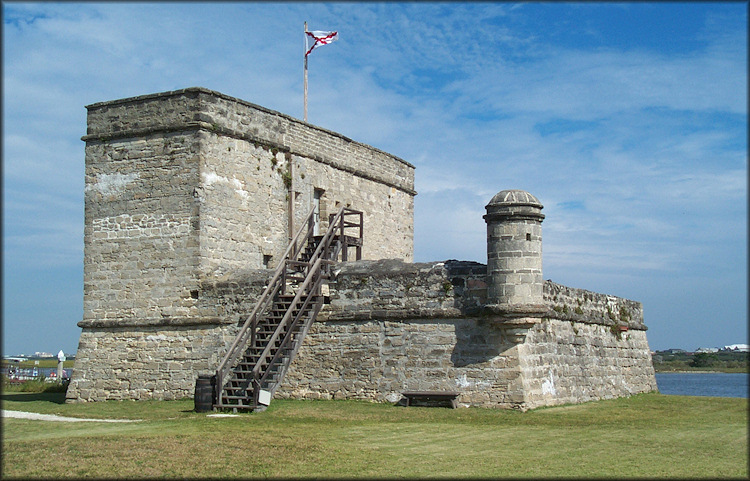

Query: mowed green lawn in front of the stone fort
[2,393,748,478]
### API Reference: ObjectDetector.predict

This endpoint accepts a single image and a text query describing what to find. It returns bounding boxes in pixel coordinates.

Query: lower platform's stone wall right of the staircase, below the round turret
[276,260,656,410]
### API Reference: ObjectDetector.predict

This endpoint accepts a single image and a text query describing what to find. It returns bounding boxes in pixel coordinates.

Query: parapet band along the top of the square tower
[83,87,416,195]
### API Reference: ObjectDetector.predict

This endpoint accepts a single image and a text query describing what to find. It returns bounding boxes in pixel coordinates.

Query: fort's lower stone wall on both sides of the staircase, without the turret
[68,255,656,404]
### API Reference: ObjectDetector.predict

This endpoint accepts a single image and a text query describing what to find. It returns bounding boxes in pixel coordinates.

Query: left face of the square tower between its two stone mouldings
[83,134,200,324]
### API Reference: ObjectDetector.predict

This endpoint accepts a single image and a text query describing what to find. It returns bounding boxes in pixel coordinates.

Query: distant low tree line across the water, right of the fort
[652,351,750,372]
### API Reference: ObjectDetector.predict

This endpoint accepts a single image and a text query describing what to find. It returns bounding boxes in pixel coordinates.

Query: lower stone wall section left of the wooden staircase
[66,269,272,402]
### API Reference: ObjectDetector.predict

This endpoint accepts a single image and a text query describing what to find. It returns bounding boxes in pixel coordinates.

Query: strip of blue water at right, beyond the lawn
[656,372,748,398]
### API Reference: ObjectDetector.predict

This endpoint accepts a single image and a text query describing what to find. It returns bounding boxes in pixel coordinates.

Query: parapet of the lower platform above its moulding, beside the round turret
[319,259,647,330]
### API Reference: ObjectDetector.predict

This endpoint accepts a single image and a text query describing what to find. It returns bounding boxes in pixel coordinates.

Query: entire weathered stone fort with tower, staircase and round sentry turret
[66,88,656,410]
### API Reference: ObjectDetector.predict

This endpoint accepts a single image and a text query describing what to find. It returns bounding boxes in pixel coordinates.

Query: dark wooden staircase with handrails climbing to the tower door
[213,207,363,412]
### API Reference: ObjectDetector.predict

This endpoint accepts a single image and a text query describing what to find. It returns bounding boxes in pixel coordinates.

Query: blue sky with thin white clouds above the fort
[2,2,748,354]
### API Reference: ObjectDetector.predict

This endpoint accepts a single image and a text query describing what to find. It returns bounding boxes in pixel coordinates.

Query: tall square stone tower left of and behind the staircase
[68,87,416,399]
